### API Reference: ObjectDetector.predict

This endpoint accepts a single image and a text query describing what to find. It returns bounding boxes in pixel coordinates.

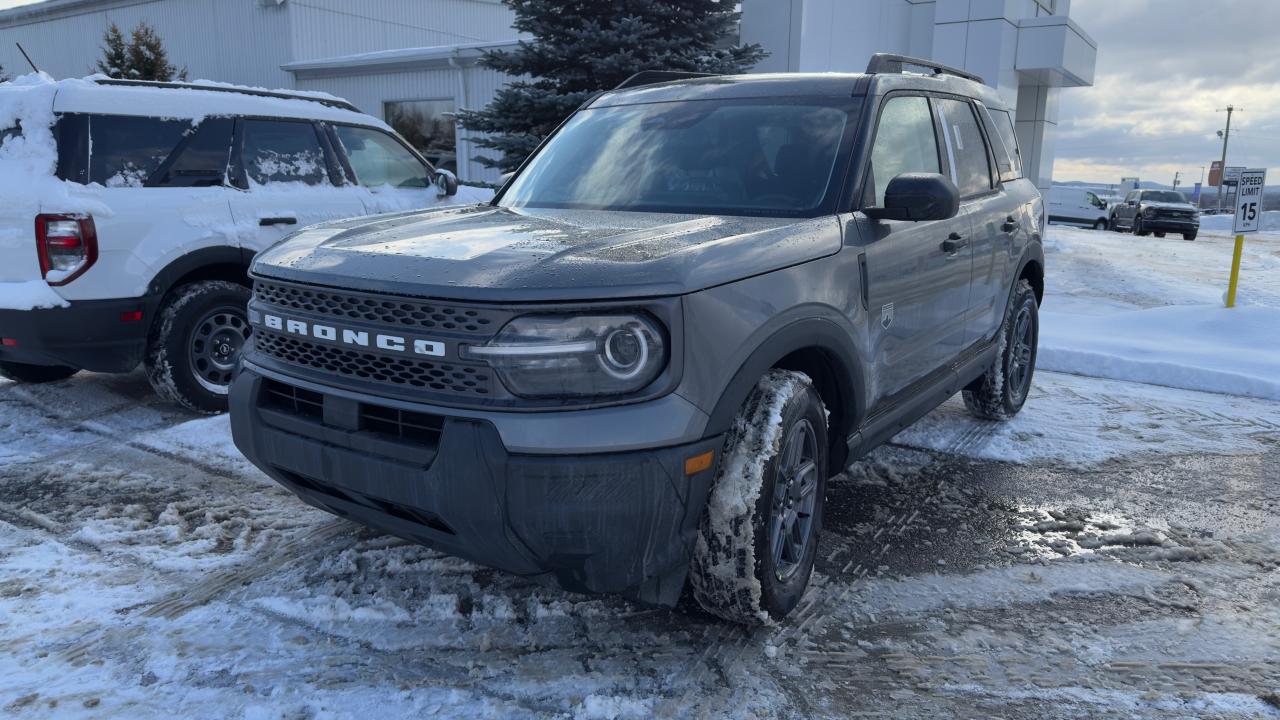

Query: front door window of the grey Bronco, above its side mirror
[868,96,942,208]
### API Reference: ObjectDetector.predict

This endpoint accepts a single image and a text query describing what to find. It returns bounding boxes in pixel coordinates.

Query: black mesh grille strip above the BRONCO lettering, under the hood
[253,281,502,336]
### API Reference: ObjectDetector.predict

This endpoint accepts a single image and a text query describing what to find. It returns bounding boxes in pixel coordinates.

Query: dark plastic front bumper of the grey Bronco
[230,368,723,606]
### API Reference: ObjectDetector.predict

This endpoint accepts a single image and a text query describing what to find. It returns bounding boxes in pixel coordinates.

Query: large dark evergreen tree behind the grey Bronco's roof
[458,0,765,170]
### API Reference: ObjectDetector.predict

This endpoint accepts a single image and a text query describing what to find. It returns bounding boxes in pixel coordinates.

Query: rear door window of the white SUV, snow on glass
[241,120,329,184]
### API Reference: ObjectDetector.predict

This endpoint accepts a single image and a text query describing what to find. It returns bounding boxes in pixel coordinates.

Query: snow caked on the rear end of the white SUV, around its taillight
[0,73,108,310]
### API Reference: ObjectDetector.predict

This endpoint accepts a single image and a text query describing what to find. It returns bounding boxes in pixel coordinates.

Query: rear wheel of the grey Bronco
[961,279,1039,420]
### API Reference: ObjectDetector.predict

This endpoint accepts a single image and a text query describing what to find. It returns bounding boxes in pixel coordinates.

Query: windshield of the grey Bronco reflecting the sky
[499,99,856,217]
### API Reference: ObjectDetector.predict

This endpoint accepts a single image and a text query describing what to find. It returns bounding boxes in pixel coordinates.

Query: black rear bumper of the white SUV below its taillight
[0,297,159,373]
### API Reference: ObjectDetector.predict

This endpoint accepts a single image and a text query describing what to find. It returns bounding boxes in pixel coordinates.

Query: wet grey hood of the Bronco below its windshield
[253,205,841,302]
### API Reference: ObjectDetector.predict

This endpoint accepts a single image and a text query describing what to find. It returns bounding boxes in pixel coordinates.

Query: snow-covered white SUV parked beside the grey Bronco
[0,74,484,411]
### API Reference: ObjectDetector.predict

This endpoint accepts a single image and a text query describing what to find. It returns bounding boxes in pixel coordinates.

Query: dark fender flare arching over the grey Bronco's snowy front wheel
[707,315,867,458]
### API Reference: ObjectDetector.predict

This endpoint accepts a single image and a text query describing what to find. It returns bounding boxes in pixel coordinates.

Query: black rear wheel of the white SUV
[146,281,250,414]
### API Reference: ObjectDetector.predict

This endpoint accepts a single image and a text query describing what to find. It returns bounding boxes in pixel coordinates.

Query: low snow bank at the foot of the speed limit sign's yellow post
[1037,305,1280,400]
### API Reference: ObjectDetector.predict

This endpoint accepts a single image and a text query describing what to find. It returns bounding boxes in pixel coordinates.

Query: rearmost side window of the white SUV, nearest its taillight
[88,115,191,187]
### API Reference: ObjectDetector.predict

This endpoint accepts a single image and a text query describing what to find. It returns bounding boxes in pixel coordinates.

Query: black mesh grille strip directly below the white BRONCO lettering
[253,328,493,397]
